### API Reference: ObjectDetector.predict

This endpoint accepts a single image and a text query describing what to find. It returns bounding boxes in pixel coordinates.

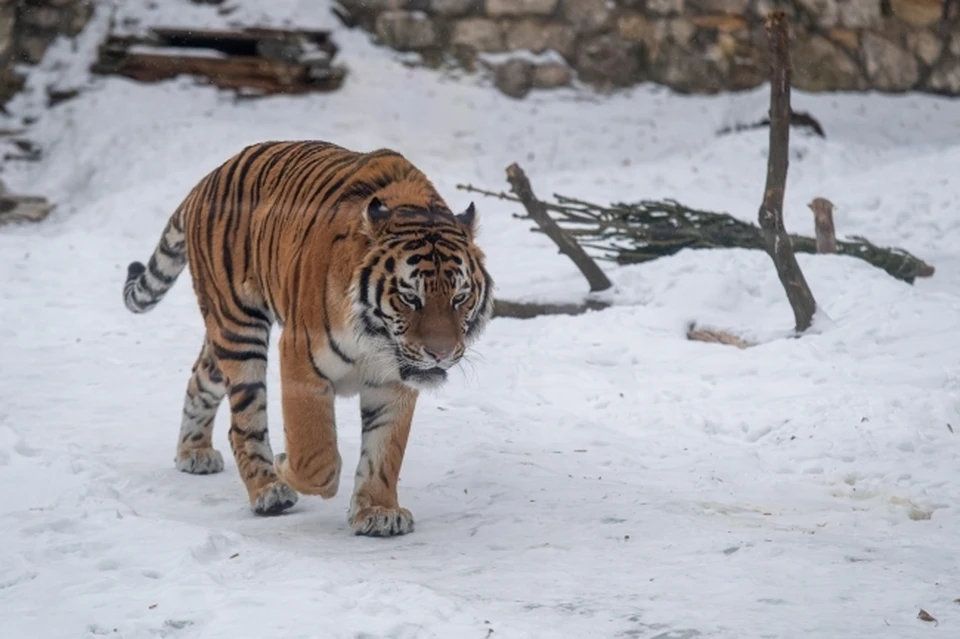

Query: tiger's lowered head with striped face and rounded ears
[352,197,493,389]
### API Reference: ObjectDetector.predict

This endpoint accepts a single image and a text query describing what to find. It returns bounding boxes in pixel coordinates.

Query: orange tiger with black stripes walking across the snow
[123,140,494,537]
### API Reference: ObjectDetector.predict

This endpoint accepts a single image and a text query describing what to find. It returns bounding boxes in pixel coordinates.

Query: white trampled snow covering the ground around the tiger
[0,0,960,639]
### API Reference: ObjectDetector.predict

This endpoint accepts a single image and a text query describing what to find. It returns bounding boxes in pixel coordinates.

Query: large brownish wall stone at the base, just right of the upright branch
[790,34,866,92]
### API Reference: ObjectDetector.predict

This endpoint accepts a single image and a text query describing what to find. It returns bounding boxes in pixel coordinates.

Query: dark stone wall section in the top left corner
[0,0,93,105]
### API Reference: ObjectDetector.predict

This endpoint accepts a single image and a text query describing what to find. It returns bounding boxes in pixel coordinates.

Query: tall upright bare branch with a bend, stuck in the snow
[758,10,817,333]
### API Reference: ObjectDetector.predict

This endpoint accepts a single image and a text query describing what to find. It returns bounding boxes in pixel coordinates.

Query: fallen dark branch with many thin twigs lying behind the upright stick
[457,184,934,284]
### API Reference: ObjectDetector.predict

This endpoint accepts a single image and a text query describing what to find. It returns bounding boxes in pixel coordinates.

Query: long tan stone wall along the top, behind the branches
[340,0,960,97]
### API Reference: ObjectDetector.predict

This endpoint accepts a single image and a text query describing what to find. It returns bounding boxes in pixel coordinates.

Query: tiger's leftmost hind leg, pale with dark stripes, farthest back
[176,340,227,475]
